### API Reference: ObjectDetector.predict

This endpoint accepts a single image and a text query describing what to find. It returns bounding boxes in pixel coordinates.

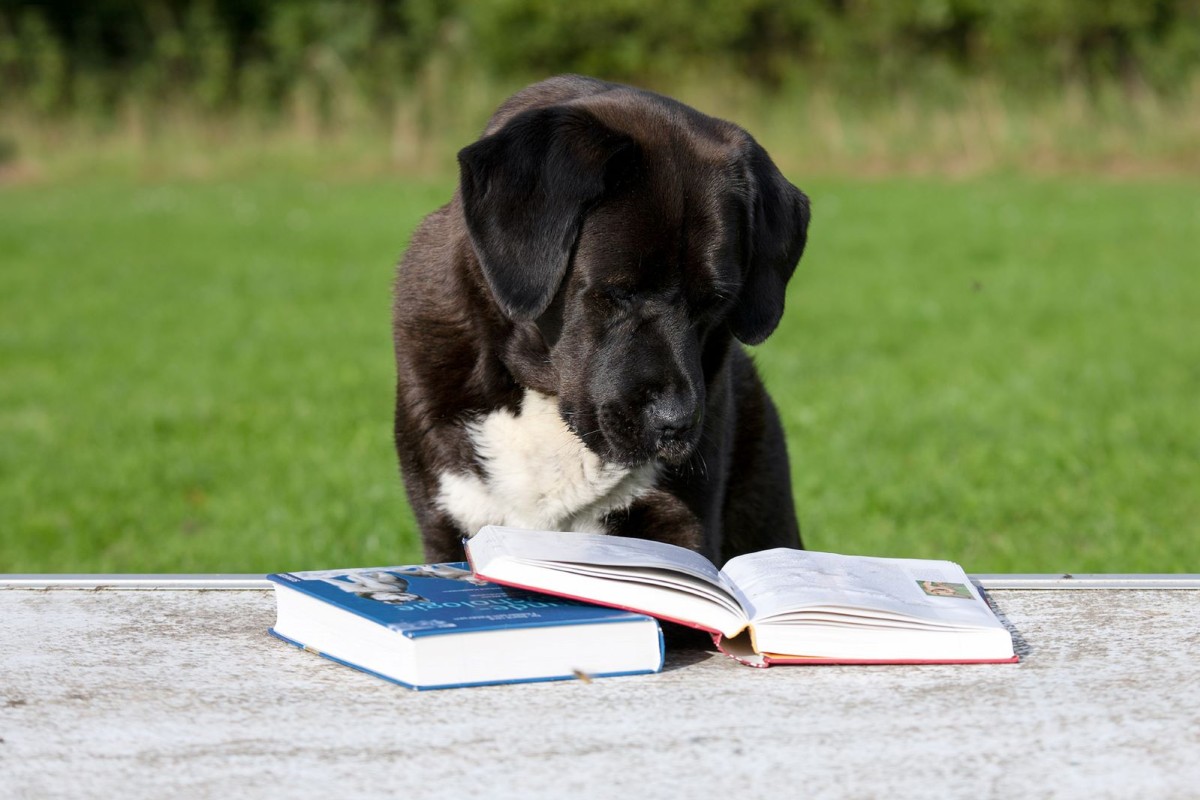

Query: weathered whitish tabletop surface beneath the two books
[0,589,1200,800]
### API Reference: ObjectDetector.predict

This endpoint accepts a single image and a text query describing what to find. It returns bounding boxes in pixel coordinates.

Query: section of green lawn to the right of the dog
[760,180,1200,572]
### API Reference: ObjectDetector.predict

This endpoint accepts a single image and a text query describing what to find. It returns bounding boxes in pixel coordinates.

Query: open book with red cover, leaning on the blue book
[466,525,1016,667]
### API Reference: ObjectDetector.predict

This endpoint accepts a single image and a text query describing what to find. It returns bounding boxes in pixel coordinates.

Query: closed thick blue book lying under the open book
[266,563,662,688]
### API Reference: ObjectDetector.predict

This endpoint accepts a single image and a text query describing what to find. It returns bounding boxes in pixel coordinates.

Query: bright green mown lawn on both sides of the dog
[0,173,1200,572]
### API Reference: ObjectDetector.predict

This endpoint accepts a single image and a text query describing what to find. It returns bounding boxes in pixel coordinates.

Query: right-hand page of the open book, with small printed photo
[724,548,1000,627]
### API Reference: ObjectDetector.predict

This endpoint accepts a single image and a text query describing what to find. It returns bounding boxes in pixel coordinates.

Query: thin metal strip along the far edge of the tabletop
[0,573,1200,591]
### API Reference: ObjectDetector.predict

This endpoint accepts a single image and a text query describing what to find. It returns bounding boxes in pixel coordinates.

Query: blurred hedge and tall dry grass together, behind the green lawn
[0,0,1200,172]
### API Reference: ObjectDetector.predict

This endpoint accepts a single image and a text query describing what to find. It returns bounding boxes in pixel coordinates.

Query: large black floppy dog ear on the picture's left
[458,106,637,319]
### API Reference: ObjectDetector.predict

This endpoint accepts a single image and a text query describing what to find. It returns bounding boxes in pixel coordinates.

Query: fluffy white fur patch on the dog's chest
[437,390,658,536]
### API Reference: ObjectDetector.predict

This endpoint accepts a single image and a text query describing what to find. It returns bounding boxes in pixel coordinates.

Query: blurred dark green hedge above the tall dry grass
[0,0,1200,114]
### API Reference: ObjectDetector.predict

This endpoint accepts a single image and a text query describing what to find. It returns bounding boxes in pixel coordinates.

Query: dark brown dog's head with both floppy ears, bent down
[458,84,809,465]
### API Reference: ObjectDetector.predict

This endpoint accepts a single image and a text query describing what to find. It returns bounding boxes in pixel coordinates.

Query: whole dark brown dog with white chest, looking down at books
[392,76,810,563]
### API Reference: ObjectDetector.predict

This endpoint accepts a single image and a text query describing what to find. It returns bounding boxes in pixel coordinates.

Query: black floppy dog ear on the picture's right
[730,140,810,344]
